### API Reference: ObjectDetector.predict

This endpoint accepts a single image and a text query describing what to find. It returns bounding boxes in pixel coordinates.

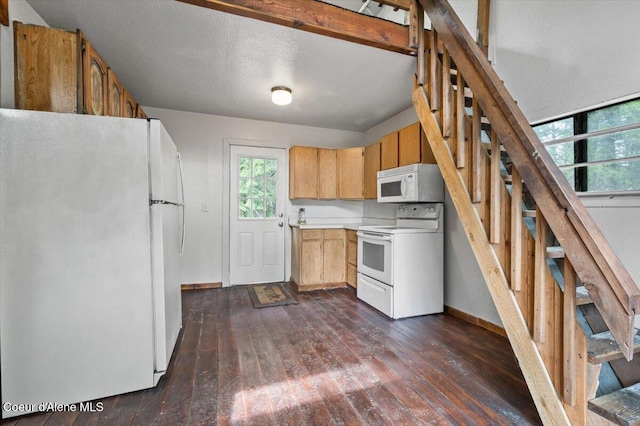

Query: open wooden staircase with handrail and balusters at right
[411,0,640,425]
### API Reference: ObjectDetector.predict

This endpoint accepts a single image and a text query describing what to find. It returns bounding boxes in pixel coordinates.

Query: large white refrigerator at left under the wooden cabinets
[0,109,184,418]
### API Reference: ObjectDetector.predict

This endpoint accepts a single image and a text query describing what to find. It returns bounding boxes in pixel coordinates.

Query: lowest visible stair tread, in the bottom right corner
[589,383,640,426]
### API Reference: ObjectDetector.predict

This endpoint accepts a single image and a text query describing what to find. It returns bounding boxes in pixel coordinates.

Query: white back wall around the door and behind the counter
[144,106,363,284]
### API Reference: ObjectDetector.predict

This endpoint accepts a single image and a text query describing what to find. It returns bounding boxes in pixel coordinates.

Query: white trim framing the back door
[221,138,291,287]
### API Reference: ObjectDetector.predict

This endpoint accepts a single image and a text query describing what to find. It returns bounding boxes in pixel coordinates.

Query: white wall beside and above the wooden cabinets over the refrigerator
[0,0,48,108]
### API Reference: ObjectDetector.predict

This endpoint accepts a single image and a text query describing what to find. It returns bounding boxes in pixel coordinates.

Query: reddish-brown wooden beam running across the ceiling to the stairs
[178,0,416,55]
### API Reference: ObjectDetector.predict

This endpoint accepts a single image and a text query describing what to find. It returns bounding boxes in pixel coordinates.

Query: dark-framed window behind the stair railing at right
[533,99,640,192]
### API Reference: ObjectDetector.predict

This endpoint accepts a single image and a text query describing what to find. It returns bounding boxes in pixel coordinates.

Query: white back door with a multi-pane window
[229,145,286,285]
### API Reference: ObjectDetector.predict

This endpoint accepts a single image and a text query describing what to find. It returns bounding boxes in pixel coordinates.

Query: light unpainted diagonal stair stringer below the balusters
[412,86,571,425]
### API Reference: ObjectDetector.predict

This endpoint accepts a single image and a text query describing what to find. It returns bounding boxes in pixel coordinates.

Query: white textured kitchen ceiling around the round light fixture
[27,0,415,131]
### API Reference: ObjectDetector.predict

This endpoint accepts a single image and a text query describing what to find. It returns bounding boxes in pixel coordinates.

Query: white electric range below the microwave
[357,203,444,319]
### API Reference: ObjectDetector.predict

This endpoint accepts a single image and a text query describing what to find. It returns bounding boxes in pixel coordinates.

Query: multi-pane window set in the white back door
[238,157,277,219]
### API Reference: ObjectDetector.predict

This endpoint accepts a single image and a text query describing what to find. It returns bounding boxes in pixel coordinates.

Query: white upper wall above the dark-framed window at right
[490,0,640,122]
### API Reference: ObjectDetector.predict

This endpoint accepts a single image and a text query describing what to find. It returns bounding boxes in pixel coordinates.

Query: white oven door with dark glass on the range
[358,231,393,286]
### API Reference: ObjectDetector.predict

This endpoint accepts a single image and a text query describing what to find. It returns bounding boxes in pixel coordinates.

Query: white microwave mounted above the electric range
[378,164,444,203]
